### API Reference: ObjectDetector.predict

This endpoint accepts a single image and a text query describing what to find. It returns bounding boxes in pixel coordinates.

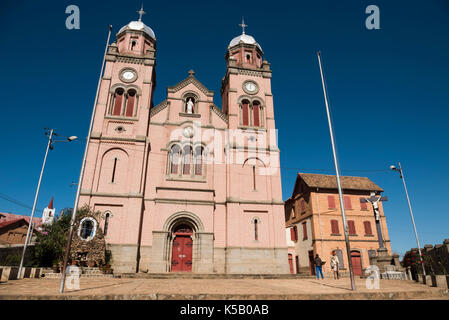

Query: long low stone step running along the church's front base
[116,272,315,279]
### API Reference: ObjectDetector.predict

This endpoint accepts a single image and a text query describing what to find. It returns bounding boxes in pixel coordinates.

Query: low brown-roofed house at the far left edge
[0,212,42,245]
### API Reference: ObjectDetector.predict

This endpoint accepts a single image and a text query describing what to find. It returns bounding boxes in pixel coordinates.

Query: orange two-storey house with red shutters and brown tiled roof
[284,173,391,275]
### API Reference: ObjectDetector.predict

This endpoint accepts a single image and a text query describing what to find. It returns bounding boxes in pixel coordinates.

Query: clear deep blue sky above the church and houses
[0,0,449,253]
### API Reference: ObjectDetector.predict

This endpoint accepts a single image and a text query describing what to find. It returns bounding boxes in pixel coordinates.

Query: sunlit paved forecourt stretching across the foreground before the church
[0,278,449,300]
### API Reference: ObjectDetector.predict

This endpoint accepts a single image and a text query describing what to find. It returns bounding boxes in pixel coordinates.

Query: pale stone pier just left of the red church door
[149,231,170,273]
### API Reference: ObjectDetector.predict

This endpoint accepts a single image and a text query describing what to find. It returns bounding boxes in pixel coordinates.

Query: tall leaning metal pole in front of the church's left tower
[59,25,112,293]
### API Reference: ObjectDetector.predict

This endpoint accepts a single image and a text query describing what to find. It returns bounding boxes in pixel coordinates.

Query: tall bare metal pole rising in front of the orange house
[317,51,356,290]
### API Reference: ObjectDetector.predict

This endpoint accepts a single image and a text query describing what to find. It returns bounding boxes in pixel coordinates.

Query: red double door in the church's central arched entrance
[171,223,193,272]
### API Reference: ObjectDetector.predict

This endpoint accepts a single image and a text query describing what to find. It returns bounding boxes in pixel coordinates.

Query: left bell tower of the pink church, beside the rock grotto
[80,8,156,272]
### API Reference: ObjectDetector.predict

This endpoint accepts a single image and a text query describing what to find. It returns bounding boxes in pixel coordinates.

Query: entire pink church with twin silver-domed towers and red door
[78,15,289,274]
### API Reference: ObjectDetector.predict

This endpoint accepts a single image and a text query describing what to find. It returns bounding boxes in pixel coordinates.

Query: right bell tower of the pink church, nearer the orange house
[221,19,288,273]
